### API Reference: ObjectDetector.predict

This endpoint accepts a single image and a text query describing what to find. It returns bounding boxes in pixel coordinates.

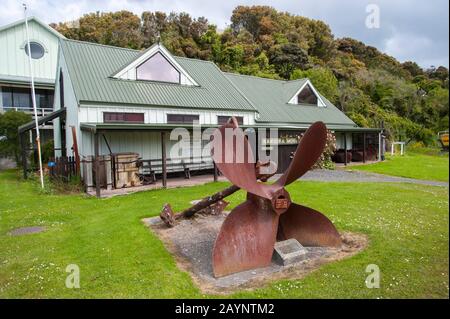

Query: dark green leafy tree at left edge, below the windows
[0,111,32,165]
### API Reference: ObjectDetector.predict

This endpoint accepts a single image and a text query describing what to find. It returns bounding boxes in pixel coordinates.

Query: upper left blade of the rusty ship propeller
[212,123,280,199]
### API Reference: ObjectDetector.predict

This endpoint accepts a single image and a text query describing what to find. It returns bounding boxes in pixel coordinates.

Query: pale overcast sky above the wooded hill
[0,0,449,68]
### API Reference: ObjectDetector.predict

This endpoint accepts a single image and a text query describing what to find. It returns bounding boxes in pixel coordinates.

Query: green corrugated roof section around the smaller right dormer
[225,73,356,127]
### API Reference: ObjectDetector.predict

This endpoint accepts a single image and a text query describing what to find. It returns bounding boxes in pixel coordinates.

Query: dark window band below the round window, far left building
[2,87,54,111]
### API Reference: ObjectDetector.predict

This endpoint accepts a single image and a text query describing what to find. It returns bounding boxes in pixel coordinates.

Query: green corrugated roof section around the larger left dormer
[61,39,255,111]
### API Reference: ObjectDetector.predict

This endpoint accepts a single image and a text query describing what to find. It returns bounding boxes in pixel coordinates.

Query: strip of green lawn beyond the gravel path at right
[351,152,449,182]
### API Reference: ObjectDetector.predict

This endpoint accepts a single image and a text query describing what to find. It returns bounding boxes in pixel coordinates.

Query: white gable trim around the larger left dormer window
[112,43,199,86]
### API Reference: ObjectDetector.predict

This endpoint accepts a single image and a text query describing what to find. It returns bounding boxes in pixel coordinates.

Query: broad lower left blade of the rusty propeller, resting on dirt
[212,200,278,277]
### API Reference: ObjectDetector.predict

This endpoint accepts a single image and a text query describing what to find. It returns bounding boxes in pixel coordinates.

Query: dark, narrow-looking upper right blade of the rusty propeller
[276,122,327,186]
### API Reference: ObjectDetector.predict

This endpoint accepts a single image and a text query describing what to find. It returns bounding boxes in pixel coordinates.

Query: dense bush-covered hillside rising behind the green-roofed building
[53,6,449,144]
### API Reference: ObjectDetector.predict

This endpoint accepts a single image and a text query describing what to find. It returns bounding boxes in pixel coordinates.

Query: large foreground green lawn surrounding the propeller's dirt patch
[0,171,449,298]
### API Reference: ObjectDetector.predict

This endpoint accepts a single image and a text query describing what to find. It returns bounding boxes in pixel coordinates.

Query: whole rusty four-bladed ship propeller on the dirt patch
[212,118,341,277]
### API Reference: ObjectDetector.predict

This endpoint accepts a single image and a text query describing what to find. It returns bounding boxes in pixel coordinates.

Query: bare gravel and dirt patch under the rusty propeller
[143,212,368,294]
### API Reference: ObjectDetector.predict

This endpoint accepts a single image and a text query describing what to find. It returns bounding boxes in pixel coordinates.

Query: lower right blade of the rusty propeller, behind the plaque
[278,203,341,247]
